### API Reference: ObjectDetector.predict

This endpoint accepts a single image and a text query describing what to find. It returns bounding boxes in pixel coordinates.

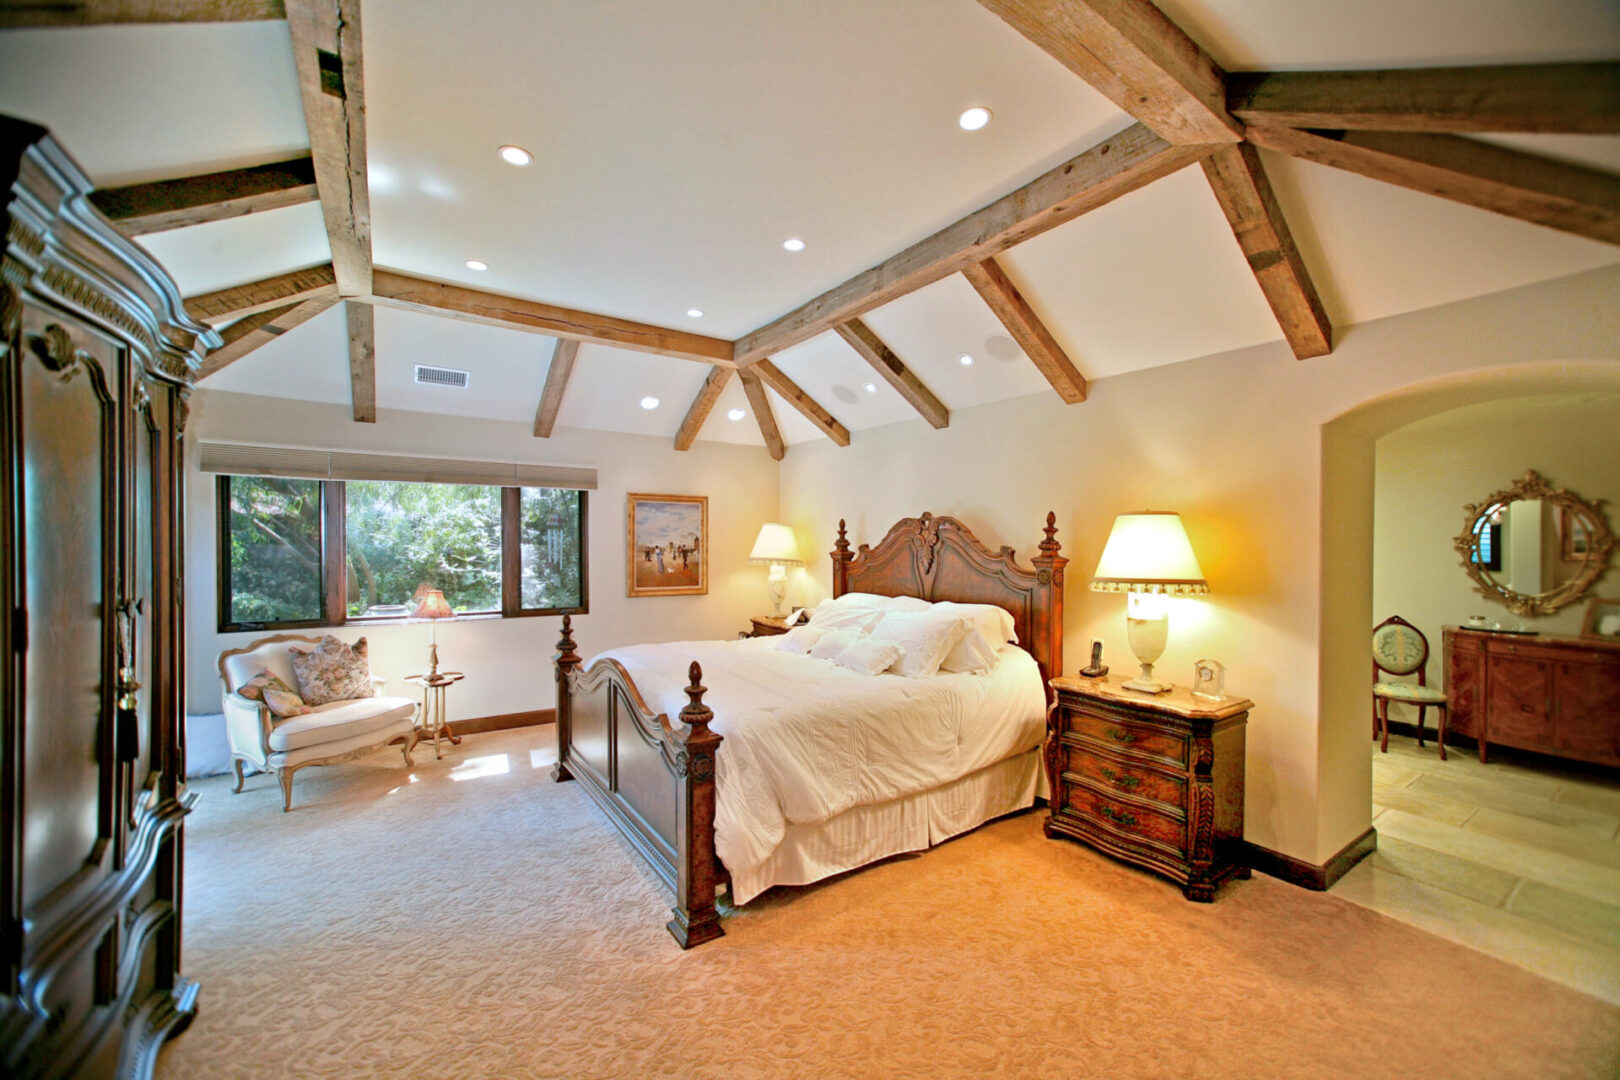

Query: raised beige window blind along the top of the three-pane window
[199,442,596,491]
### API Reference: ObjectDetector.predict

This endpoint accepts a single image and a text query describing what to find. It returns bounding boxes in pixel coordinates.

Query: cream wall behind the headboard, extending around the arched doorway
[781,269,1620,863]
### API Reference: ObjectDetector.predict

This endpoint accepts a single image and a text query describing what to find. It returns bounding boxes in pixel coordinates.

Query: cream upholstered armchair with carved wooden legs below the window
[219,633,418,811]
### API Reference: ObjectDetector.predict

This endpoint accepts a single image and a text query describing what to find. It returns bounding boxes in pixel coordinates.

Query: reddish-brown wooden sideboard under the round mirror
[1445,627,1620,766]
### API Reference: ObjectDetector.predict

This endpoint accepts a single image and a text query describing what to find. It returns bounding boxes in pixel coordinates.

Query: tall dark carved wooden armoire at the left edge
[0,117,219,1078]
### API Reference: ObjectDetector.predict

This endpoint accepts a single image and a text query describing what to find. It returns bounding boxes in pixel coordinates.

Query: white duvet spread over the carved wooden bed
[591,638,1047,904]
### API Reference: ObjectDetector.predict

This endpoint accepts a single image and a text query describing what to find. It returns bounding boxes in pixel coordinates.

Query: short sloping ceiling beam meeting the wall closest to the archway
[1202,142,1333,359]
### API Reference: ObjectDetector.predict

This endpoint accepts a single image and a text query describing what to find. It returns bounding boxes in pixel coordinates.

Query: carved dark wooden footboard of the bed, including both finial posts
[552,615,726,949]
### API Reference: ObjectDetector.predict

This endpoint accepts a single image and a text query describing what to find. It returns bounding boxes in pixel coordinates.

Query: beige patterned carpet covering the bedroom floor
[159,727,1620,1080]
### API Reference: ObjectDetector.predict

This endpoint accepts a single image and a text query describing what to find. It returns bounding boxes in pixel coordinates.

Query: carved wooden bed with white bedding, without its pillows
[552,513,1068,949]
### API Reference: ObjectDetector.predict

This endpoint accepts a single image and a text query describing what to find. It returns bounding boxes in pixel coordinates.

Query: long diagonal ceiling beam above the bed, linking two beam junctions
[735,125,1213,364]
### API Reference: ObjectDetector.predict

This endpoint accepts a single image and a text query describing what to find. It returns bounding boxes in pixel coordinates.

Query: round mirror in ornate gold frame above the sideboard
[1455,470,1615,615]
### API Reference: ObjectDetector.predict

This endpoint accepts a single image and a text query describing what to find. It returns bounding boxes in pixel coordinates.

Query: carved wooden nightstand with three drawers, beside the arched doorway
[1045,677,1254,902]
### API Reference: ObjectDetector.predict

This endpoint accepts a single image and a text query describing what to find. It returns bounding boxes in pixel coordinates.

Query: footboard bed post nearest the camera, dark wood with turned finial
[667,661,726,949]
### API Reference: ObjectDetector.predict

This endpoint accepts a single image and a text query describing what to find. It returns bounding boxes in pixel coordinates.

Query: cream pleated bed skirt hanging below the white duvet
[731,746,1042,905]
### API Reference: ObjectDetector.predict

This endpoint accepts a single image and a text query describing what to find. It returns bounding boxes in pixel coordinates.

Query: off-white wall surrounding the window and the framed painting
[186,389,778,719]
